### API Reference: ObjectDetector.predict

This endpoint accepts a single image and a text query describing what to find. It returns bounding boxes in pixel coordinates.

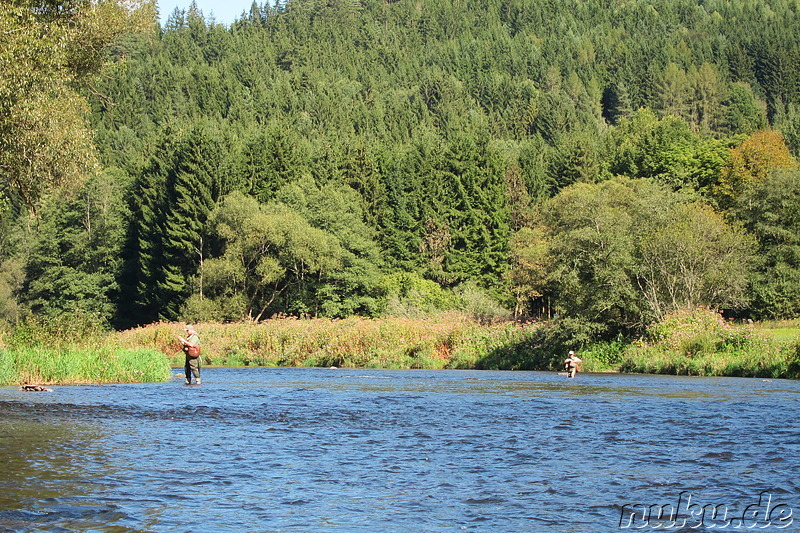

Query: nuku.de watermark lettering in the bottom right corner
[619,491,794,530]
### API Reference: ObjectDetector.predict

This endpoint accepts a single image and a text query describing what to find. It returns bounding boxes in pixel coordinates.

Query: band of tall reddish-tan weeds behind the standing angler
[112,314,548,369]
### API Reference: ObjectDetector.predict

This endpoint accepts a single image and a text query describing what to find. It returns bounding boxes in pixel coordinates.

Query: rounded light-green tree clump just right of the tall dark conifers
[202,185,388,321]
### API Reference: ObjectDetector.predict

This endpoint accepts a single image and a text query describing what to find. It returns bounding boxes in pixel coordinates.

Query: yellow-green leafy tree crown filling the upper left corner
[0,0,155,210]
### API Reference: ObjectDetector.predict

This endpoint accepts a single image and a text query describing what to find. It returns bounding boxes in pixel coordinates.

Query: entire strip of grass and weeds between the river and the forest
[0,309,800,383]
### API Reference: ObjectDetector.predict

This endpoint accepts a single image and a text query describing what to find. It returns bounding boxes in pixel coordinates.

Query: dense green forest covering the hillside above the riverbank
[0,0,800,338]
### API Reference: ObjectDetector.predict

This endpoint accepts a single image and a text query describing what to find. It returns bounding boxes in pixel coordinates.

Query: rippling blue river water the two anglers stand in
[0,368,800,533]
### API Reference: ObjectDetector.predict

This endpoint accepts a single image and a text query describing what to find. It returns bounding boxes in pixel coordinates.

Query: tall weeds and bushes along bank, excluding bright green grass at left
[116,308,800,379]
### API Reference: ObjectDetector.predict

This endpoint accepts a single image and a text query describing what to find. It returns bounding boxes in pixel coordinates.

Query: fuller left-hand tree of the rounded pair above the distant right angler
[542,180,664,329]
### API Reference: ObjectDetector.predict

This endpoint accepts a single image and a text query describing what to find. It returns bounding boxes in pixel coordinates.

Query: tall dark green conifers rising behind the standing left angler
[121,123,222,322]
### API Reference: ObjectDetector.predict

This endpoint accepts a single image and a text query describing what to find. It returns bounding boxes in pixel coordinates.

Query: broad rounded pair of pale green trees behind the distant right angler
[515,179,754,333]
